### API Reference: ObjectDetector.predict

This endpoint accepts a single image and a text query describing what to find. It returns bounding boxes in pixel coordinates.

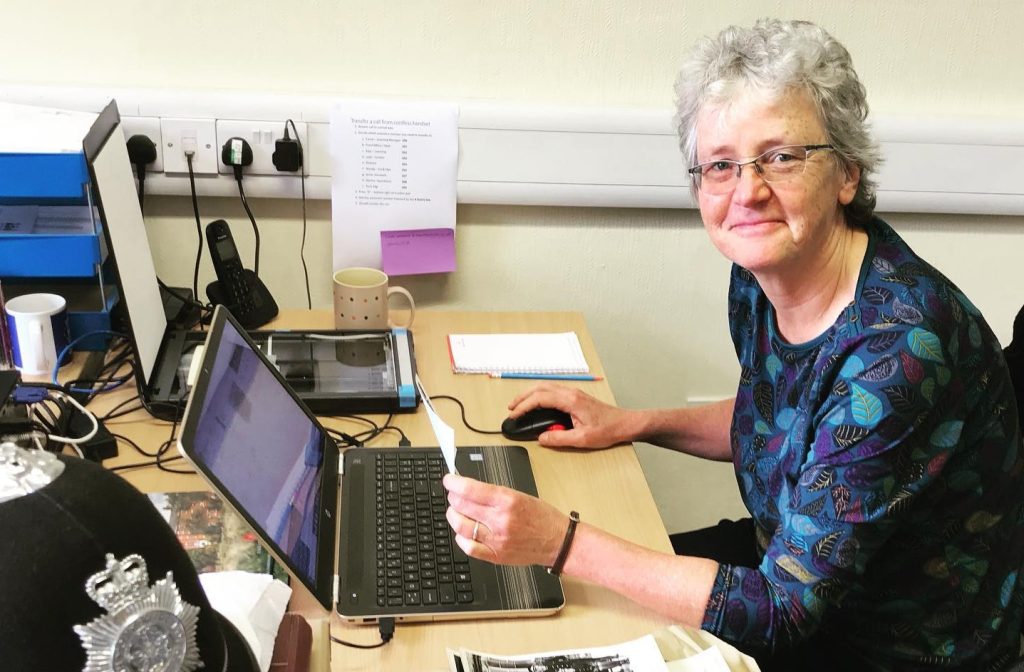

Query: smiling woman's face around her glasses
[696,91,860,277]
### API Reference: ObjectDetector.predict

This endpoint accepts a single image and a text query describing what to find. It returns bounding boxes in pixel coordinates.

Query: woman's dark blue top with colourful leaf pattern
[702,219,1024,670]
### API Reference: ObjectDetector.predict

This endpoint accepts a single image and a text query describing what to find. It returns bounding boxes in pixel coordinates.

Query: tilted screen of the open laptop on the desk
[181,309,334,593]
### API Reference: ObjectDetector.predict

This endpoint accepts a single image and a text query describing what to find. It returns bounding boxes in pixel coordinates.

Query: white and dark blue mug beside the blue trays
[4,294,71,375]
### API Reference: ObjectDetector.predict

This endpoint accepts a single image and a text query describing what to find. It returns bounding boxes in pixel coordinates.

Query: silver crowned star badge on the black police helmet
[75,553,203,672]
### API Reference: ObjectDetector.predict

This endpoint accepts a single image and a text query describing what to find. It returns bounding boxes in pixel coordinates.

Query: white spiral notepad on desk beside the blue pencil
[449,331,590,373]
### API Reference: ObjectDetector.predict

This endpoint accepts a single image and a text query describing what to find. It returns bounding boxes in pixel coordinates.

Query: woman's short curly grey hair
[676,18,882,226]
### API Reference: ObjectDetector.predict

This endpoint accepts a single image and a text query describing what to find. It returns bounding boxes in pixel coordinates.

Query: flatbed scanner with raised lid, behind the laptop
[83,100,419,418]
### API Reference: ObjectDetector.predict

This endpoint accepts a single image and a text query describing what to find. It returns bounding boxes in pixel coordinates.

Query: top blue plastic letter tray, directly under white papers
[0,152,89,203]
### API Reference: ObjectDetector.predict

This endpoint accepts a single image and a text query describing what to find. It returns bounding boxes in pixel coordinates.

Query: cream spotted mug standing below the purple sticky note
[334,266,416,331]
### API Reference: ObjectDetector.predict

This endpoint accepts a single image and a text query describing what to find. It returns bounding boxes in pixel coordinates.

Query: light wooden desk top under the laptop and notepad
[90,310,672,671]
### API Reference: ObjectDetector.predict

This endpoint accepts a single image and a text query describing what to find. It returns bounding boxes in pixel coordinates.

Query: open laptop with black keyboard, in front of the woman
[178,307,565,623]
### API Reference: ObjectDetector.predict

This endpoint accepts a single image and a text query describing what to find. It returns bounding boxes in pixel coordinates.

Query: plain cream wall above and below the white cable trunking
[8,0,1024,531]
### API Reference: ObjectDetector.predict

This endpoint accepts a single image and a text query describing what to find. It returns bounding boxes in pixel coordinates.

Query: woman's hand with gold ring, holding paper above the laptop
[443,473,568,565]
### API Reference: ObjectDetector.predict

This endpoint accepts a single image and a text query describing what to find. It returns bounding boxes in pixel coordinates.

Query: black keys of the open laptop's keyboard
[376,451,473,607]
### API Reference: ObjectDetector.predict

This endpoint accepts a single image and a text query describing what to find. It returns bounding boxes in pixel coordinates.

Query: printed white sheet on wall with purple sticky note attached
[331,100,459,276]
